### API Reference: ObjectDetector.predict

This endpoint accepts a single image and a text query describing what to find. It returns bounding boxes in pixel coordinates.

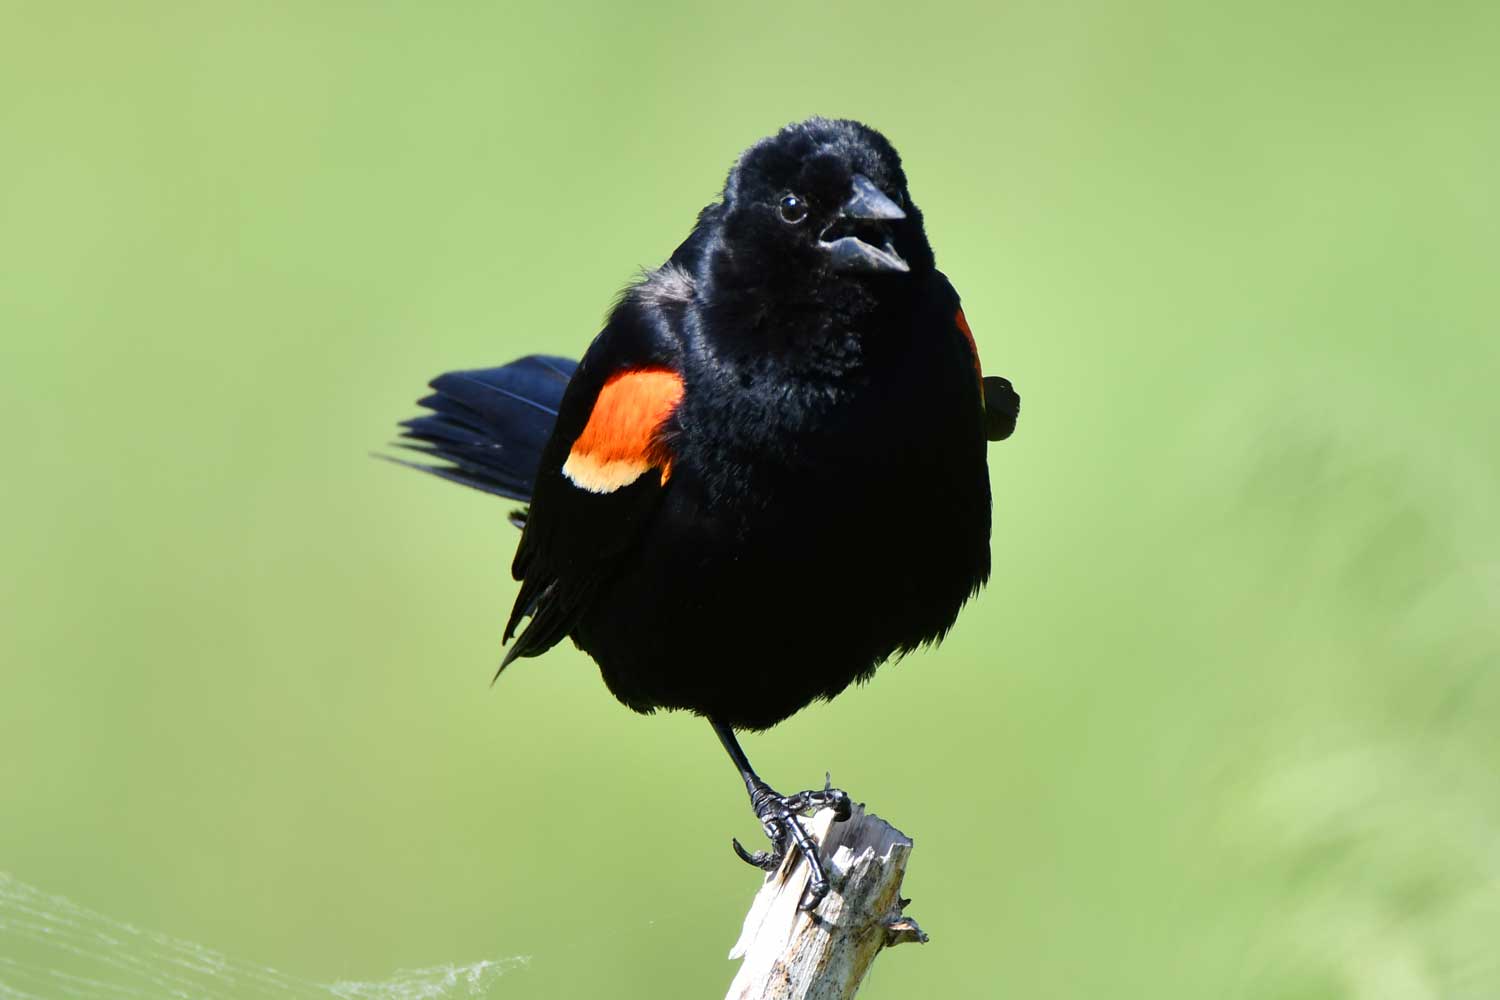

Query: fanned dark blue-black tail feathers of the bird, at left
[392,354,578,504]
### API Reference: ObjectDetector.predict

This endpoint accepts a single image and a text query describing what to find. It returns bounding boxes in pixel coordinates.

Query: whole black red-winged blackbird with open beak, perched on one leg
[404,118,1020,907]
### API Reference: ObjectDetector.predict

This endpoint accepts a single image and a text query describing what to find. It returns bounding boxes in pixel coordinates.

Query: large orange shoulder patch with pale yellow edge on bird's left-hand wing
[563,367,683,493]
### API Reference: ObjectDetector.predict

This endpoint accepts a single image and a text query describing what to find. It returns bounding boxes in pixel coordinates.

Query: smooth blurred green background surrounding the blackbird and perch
[0,0,1500,1000]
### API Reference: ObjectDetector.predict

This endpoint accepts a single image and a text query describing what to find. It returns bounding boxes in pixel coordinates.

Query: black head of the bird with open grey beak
[708,118,933,295]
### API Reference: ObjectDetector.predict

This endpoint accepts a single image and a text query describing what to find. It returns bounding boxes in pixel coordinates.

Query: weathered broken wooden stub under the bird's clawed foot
[726,805,927,1000]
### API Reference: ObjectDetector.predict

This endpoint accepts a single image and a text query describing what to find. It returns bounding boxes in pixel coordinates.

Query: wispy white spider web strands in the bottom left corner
[0,873,528,1000]
